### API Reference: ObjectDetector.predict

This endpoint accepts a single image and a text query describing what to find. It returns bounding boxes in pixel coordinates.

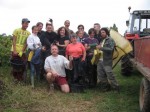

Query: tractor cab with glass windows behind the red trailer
[125,10,150,40]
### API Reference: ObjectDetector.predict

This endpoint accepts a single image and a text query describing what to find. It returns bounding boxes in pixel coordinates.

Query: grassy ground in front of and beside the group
[0,66,142,112]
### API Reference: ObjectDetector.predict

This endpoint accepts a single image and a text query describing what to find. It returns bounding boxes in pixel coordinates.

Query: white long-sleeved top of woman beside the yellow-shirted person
[27,33,41,50]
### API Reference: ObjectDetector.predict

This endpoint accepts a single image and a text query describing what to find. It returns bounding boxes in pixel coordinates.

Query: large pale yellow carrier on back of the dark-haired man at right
[110,29,133,66]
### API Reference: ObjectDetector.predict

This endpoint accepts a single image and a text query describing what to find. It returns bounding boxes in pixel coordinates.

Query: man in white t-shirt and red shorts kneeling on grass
[44,45,73,93]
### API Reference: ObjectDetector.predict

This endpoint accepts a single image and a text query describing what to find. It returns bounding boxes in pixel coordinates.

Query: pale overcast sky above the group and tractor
[0,0,150,34]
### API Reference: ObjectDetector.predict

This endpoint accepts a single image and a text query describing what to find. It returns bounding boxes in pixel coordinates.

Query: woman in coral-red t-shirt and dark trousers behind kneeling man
[66,34,86,84]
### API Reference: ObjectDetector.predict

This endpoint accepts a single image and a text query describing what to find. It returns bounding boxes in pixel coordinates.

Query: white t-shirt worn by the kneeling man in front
[44,55,70,77]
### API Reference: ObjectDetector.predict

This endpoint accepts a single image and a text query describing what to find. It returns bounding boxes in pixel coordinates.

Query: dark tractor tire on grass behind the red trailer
[121,55,133,76]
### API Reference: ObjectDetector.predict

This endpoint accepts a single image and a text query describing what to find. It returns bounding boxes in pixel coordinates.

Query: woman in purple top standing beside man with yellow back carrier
[84,28,99,87]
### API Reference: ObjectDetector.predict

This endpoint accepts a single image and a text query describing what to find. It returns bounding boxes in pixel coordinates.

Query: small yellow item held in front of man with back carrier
[91,49,101,65]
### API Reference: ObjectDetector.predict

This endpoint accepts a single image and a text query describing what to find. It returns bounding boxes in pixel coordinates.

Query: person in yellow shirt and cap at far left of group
[11,18,30,81]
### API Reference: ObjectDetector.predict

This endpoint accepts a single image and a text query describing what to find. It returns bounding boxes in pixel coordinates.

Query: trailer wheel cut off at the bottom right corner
[139,78,150,112]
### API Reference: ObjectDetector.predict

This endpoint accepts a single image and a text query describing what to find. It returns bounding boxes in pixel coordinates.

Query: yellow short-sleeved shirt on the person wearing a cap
[11,28,30,53]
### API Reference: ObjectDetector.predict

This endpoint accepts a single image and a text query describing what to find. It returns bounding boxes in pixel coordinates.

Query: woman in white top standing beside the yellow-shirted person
[27,26,41,88]
